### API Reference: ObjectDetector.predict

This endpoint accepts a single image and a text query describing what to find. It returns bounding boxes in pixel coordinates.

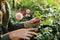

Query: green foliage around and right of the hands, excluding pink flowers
[7,0,60,40]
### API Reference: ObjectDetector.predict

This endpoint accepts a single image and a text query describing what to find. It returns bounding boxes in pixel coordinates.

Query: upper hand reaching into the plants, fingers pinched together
[24,17,40,28]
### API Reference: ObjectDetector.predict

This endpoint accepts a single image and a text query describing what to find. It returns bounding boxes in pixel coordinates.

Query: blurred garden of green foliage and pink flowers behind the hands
[7,0,60,40]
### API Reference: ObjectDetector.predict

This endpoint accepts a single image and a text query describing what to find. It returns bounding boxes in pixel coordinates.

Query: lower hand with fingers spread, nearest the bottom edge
[9,28,37,40]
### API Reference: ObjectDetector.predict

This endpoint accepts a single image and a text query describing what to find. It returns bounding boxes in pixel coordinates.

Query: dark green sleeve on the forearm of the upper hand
[8,21,24,31]
